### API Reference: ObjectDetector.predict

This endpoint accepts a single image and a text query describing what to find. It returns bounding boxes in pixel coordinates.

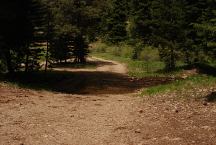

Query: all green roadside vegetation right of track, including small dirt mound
[91,42,216,99]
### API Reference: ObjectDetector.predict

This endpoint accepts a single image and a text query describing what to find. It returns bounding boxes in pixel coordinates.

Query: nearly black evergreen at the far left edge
[0,0,45,72]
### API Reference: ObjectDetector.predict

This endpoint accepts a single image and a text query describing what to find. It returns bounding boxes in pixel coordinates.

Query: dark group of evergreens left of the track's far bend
[0,0,102,72]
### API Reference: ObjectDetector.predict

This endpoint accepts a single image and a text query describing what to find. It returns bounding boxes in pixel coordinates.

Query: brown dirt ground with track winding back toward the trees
[0,58,216,145]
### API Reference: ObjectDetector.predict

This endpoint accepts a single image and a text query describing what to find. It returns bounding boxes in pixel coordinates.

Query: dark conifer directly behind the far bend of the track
[102,0,128,43]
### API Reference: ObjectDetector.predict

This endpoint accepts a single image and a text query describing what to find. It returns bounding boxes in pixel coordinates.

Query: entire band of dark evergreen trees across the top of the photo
[0,0,216,72]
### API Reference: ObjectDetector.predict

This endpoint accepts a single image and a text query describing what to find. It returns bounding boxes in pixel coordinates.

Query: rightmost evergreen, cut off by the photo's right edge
[193,0,216,58]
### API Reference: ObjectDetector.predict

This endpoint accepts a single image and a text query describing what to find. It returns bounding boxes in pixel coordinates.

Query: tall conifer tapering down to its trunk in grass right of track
[151,0,185,69]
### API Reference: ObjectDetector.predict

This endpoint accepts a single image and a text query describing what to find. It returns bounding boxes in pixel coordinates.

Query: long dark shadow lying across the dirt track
[1,71,176,94]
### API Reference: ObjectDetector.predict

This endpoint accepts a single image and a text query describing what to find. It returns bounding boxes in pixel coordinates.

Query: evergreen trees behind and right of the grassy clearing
[103,0,216,69]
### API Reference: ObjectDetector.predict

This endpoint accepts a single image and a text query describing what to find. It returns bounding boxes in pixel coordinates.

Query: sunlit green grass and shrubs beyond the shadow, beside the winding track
[91,42,184,78]
